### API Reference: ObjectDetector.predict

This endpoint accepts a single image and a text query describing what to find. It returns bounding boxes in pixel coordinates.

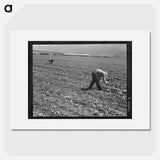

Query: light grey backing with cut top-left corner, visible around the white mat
[4,5,156,156]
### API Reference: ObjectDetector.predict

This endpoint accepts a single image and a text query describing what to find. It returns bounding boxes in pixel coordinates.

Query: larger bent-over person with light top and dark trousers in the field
[87,69,109,90]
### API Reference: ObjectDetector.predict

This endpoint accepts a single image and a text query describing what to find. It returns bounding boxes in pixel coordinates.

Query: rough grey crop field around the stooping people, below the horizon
[33,55,127,118]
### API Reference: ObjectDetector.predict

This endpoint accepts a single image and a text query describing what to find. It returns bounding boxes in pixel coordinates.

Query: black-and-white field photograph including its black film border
[28,41,132,119]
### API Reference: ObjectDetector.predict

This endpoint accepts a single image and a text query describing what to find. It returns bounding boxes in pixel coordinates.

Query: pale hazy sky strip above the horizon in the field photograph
[33,44,126,56]
